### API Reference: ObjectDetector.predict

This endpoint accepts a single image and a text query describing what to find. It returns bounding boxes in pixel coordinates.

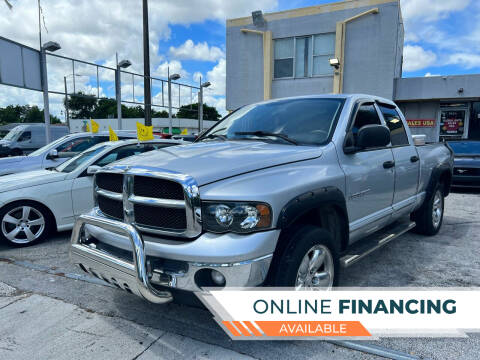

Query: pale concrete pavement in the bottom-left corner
[0,282,251,360]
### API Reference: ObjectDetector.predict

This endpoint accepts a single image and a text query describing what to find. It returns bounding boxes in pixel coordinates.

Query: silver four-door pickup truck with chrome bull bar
[71,94,453,303]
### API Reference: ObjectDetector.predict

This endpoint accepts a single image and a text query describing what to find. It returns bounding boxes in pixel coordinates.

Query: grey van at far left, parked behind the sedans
[0,124,68,157]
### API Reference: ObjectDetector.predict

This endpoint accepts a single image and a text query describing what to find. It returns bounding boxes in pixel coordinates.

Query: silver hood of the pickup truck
[112,140,322,185]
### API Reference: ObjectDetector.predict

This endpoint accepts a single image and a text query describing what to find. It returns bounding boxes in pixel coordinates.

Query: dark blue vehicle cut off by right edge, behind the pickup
[448,140,480,188]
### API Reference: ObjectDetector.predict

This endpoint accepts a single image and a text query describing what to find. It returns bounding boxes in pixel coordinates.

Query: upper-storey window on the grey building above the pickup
[273,33,335,79]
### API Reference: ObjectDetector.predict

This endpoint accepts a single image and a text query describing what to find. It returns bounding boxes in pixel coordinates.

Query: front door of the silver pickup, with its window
[338,102,395,242]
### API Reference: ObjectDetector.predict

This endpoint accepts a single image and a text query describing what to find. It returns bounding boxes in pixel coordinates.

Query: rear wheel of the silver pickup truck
[411,182,445,236]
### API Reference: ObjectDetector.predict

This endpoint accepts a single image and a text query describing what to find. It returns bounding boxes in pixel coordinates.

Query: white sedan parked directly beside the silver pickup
[0,139,179,246]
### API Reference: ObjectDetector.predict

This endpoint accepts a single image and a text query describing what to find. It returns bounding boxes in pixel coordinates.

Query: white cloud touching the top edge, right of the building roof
[401,0,470,21]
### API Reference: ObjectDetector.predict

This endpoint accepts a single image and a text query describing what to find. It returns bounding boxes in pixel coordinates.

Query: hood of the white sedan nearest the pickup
[0,170,68,193]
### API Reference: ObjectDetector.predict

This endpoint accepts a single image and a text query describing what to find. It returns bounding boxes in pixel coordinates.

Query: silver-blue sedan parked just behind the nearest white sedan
[0,130,137,176]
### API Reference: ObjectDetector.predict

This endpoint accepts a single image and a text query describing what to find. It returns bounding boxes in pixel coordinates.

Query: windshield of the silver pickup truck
[200,98,344,145]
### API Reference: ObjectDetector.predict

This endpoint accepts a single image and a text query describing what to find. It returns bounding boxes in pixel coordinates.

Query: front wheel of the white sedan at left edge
[0,201,53,247]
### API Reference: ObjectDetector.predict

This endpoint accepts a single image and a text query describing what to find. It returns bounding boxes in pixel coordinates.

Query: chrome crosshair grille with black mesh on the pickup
[95,171,201,238]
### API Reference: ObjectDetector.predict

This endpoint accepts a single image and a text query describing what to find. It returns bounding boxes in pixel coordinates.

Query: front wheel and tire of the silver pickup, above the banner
[269,225,340,289]
